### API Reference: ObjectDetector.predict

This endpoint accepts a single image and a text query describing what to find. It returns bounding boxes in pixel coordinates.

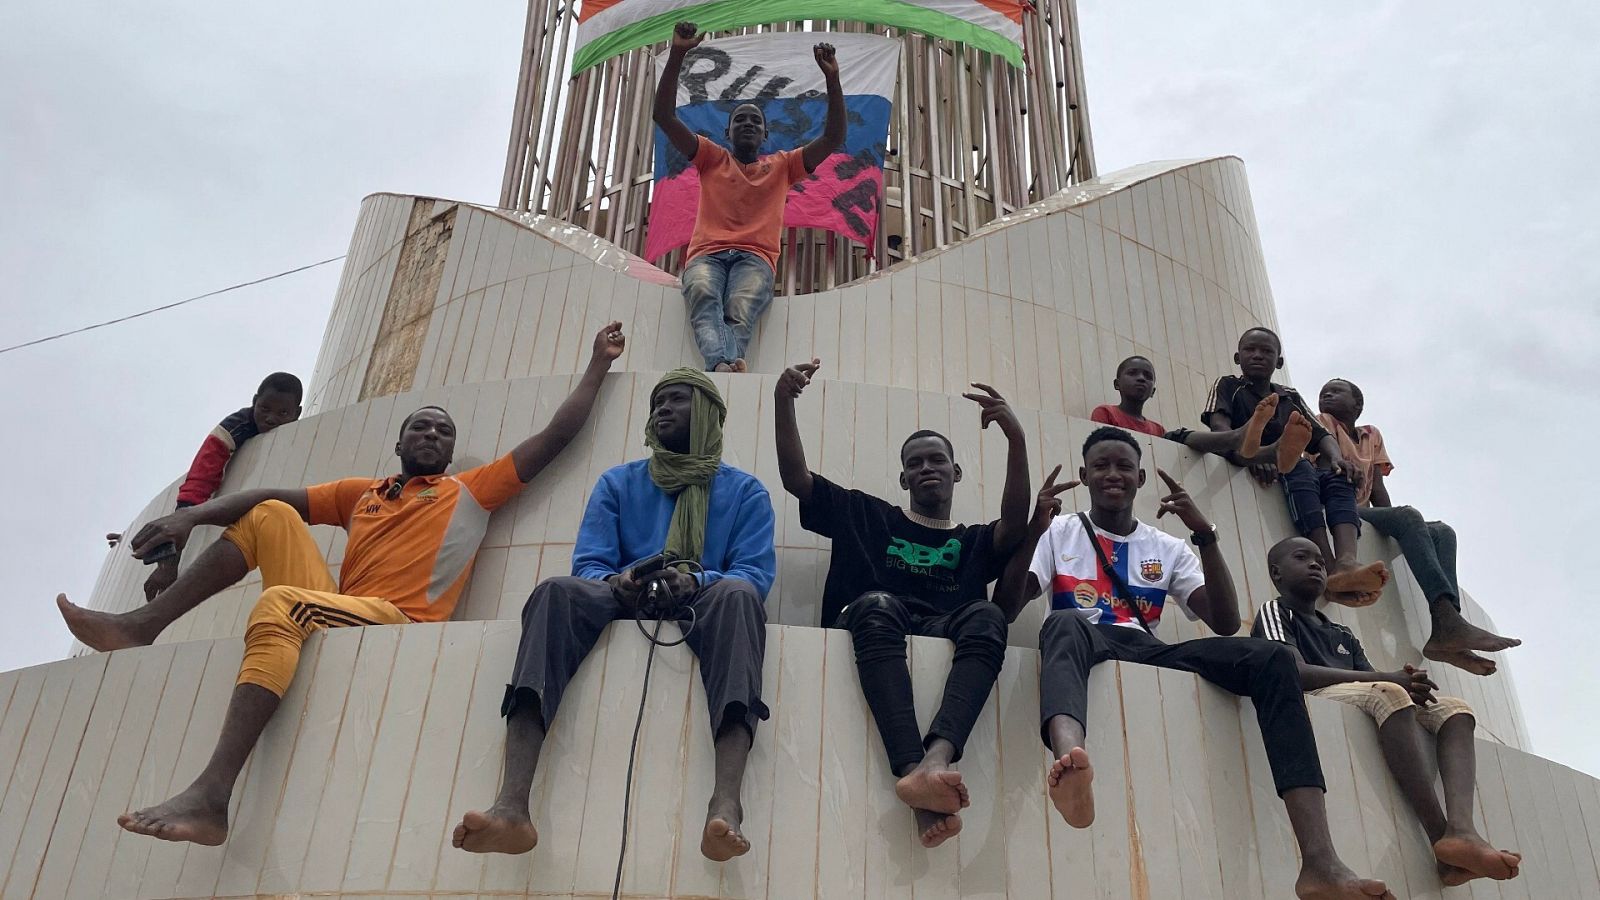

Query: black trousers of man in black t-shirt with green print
[842,591,1006,775]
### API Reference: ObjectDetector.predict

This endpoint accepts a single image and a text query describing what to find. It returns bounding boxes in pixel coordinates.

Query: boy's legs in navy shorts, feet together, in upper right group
[1282,460,1389,607]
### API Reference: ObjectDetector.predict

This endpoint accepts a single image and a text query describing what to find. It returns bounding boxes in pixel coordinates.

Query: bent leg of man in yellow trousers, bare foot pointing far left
[56,500,329,650]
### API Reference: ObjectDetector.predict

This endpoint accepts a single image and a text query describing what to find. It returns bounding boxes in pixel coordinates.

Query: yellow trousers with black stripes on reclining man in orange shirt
[222,500,411,697]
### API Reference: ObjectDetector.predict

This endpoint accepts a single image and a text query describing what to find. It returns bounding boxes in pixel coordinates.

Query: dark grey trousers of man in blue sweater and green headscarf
[501,577,768,735]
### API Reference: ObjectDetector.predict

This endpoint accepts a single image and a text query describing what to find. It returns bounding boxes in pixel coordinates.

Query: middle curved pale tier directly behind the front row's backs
[88,372,1526,746]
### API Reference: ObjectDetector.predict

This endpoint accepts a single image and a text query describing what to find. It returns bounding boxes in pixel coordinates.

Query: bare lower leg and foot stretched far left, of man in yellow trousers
[56,540,250,650]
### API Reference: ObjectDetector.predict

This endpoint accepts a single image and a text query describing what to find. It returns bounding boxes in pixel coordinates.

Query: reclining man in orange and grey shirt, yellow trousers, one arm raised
[56,322,624,844]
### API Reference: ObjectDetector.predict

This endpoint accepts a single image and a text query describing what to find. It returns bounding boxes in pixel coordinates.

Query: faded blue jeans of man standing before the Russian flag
[682,250,773,372]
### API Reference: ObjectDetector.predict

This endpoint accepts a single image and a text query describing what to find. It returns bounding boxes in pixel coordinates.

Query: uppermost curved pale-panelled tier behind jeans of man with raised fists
[306,157,1277,424]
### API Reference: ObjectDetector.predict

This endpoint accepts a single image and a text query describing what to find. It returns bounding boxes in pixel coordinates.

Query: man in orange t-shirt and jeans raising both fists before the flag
[654,22,845,372]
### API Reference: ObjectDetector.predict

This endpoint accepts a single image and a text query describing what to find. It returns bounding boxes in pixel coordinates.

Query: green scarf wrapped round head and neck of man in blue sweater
[645,368,728,562]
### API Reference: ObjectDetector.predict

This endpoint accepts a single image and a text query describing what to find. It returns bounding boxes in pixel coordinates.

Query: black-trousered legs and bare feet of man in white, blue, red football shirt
[1038,610,1394,900]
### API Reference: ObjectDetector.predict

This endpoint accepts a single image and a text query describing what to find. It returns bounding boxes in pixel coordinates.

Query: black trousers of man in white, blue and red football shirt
[1038,610,1326,796]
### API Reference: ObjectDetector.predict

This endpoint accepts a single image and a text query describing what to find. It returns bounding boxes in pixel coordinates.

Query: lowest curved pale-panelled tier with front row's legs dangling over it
[0,621,1600,900]
